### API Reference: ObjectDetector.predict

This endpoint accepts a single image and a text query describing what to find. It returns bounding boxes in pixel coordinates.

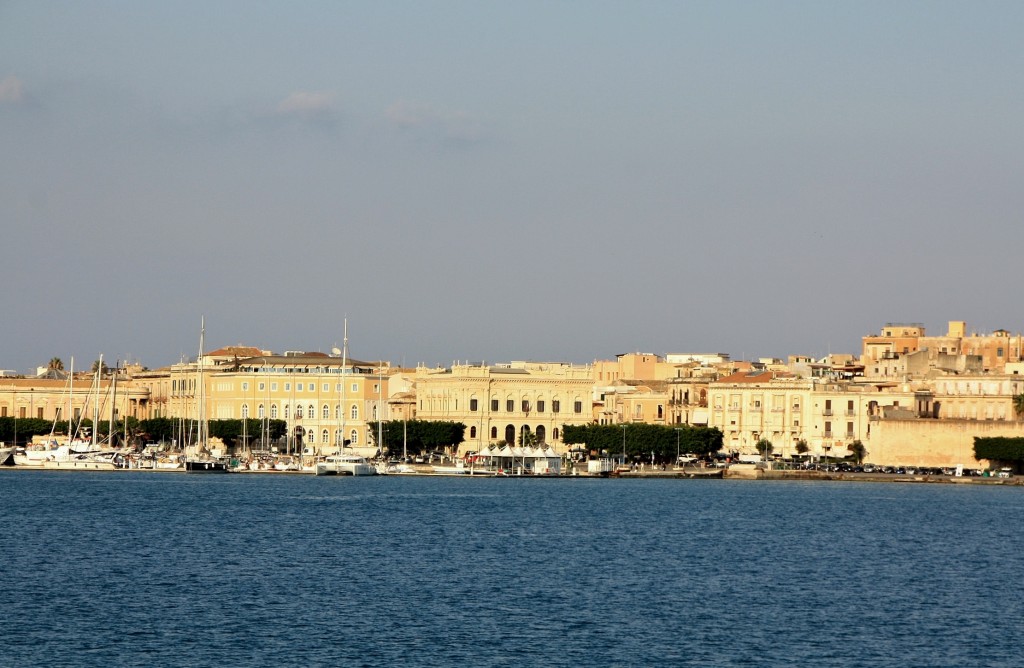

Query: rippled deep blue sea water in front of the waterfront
[0,471,1024,667]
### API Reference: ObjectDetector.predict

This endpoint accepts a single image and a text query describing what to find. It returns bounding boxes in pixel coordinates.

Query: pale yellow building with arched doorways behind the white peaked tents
[415,362,594,454]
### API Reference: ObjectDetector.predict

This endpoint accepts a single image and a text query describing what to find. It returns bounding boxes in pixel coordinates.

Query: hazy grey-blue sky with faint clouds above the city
[0,0,1024,373]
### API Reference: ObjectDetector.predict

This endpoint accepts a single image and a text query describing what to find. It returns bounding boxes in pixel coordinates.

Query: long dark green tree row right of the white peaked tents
[562,423,722,462]
